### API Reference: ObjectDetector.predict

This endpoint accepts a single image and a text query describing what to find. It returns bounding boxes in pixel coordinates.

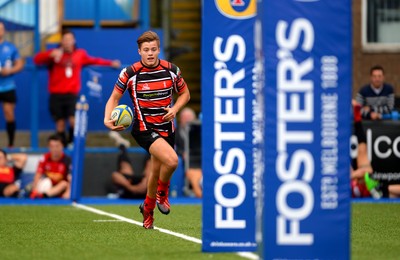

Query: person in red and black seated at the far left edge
[0,149,27,198]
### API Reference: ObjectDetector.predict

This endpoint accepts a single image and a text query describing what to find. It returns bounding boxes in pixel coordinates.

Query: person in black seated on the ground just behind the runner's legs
[111,144,151,199]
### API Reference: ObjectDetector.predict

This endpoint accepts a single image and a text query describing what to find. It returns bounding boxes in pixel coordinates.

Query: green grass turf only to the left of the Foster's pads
[0,205,242,260]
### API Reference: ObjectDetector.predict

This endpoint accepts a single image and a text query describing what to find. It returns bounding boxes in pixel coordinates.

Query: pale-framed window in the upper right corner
[362,0,400,52]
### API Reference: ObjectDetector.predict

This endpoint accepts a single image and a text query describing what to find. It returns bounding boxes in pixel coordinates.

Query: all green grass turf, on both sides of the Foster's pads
[0,204,400,260]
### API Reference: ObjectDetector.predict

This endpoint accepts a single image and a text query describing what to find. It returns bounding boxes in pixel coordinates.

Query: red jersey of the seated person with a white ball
[37,153,71,185]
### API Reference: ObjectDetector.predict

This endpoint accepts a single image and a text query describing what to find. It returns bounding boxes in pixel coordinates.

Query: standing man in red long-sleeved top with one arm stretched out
[34,30,121,145]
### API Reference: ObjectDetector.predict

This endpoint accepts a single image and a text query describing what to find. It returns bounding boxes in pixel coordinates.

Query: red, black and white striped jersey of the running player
[114,60,187,137]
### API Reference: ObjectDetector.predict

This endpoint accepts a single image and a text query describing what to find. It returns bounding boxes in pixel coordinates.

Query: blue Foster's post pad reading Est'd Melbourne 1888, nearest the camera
[257,0,352,259]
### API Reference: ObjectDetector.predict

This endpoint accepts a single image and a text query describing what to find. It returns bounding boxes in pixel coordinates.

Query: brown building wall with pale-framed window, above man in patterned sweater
[353,0,400,100]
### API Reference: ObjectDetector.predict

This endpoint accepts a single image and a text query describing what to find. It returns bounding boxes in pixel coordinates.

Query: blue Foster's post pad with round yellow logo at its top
[202,0,263,252]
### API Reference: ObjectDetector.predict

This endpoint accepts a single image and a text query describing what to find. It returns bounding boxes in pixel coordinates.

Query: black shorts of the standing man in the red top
[49,94,78,121]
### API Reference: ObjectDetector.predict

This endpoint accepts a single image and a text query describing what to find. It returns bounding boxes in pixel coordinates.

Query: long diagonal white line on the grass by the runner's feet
[72,202,259,260]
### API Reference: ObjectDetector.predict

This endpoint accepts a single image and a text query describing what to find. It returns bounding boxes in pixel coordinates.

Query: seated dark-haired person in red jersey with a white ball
[30,134,71,199]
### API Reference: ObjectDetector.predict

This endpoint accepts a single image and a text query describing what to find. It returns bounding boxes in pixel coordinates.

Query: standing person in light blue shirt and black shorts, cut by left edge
[0,22,24,148]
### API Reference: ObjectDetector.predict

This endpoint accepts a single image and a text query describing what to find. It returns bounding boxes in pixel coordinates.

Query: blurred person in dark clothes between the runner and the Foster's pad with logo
[176,107,203,198]
